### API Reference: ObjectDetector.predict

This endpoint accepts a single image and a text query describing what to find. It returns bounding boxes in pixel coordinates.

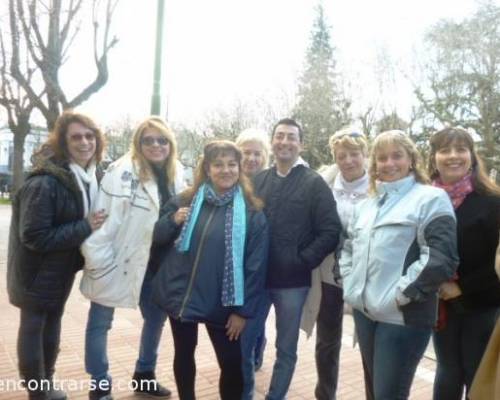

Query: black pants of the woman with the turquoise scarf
[169,318,243,400]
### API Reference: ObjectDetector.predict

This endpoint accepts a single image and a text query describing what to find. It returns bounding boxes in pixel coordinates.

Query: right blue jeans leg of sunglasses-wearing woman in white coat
[135,271,167,372]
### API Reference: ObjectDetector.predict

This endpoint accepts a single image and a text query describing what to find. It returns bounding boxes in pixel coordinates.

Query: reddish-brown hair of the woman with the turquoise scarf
[181,140,264,210]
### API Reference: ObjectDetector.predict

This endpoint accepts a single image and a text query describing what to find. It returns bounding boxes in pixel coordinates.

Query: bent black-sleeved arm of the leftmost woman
[19,175,92,252]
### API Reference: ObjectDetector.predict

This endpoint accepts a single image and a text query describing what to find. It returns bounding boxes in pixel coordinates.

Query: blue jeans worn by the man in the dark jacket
[266,287,309,400]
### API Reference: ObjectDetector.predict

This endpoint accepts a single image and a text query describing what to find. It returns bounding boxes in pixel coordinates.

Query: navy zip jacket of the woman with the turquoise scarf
[153,198,268,326]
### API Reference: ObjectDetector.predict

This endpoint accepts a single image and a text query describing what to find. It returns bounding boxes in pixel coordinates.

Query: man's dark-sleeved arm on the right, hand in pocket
[299,176,342,268]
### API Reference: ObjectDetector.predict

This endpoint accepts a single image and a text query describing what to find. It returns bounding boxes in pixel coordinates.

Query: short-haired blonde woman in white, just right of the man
[301,128,369,400]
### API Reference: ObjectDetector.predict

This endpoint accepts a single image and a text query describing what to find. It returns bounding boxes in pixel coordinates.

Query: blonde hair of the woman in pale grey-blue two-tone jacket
[368,130,429,193]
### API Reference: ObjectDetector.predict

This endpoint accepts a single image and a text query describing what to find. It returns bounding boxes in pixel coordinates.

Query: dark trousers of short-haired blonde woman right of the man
[314,282,344,400]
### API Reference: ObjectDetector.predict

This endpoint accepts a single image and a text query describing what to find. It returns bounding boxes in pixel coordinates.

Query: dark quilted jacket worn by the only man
[254,165,342,288]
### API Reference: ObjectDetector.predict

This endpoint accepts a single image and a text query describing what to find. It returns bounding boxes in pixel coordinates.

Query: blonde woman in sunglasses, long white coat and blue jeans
[80,117,183,400]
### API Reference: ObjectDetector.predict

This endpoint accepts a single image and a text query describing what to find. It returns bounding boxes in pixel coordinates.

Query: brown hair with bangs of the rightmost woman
[427,127,500,196]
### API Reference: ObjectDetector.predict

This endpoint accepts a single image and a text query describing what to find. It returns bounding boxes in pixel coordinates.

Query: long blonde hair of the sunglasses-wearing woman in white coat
[130,116,177,184]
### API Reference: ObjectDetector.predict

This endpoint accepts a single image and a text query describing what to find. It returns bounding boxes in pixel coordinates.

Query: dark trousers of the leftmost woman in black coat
[17,308,63,398]
